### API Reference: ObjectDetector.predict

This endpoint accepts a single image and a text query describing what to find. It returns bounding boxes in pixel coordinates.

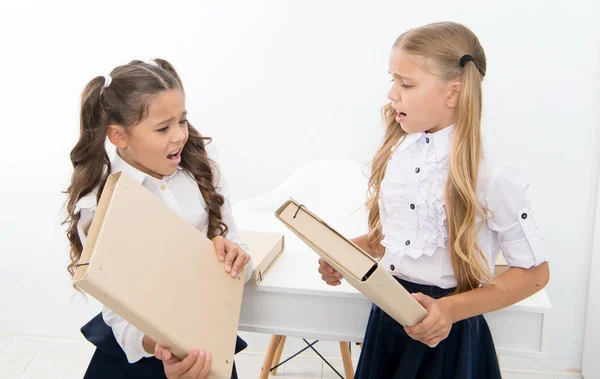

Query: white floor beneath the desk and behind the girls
[0,336,581,379]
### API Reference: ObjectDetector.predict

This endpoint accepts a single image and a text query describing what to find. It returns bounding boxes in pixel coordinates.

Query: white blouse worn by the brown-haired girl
[75,145,253,363]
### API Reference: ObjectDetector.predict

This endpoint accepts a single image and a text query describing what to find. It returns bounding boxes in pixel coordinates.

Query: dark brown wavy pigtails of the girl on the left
[63,59,227,276]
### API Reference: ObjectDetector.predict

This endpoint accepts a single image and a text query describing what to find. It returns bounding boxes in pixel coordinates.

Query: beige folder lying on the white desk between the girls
[240,230,285,284]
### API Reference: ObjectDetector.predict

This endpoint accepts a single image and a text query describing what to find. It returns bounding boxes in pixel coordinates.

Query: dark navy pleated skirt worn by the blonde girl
[355,278,502,379]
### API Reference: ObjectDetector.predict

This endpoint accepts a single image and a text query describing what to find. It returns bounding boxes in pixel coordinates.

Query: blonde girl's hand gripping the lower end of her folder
[404,293,454,347]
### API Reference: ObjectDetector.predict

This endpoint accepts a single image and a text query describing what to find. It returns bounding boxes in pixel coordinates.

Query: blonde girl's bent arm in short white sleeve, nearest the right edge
[405,165,550,345]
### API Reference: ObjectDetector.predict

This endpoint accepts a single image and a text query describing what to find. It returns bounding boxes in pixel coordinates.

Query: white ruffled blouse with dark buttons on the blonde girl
[379,126,547,288]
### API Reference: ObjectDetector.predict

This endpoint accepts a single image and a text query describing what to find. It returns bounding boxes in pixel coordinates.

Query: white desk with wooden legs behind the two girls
[232,211,552,358]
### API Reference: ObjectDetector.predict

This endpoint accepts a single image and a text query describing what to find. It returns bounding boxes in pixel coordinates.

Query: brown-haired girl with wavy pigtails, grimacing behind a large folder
[65,59,252,379]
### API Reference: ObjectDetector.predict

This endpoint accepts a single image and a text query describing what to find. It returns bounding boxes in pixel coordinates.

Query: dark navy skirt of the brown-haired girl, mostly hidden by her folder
[81,313,248,379]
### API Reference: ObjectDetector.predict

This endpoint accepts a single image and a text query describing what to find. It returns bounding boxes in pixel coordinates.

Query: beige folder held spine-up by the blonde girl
[275,200,427,326]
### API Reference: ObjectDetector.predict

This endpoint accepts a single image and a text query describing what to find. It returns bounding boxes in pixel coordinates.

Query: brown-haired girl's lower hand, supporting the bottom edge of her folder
[154,344,212,379]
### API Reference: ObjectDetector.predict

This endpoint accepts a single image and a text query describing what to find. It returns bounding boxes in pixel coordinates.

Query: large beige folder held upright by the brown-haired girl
[73,172,245,378]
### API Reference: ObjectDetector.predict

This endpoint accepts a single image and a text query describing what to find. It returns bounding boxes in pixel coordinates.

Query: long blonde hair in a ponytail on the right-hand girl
[367,22,494,293]
